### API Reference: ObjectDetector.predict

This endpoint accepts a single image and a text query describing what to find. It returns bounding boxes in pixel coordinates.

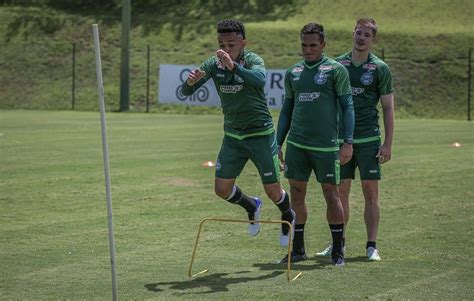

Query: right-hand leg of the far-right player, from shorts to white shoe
[358,143,381,260]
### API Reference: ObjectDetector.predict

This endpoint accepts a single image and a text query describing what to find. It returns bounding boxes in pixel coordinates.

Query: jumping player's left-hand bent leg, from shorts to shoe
[214,136,261,236]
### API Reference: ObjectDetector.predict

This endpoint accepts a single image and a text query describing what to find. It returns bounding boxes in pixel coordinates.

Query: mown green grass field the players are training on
[0,110,474,300]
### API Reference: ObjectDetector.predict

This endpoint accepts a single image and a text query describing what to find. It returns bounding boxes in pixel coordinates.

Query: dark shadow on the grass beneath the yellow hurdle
[145,271,284,294]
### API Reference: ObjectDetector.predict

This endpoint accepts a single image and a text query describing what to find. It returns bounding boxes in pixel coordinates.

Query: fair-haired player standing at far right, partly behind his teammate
[318,19,394,260]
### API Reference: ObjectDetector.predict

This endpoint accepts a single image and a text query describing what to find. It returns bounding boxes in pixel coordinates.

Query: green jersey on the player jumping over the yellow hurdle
[182,50,274,139]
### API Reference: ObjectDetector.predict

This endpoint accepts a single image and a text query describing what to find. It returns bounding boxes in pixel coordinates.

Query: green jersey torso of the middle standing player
[285,55,351,151]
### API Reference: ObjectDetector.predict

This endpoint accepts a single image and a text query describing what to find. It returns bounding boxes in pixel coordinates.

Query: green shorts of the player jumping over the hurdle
[216,132,280,184]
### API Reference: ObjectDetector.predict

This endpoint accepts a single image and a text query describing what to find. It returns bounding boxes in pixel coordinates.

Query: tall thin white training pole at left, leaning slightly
[92,24,118,301]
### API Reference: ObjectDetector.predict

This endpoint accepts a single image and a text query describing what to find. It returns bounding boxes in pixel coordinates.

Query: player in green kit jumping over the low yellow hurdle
[182,20,295,246]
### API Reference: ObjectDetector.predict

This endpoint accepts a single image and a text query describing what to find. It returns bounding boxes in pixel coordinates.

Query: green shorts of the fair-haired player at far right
[341,141,381,180]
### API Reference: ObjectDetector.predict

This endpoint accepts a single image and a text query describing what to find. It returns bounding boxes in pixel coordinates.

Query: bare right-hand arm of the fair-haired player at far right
[377,93,395,164]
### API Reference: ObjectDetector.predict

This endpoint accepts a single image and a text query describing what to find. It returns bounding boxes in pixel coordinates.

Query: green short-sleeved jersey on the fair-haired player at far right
[336,52,393,143]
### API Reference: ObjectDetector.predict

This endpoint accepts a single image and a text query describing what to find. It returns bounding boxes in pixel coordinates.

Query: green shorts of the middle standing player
[285,143,340,184]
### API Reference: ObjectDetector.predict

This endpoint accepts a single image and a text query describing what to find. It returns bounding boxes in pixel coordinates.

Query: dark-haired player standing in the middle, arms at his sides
[277,23,354,266]
